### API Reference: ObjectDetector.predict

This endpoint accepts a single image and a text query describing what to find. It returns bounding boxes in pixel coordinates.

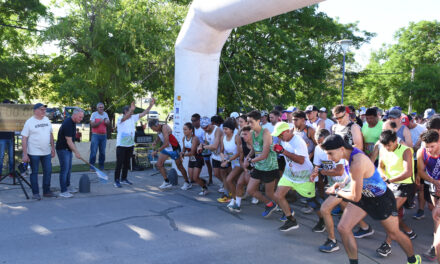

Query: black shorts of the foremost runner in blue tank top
[351,188,398,221]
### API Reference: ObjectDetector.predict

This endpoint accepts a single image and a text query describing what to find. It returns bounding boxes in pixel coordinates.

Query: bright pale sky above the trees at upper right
[318,0,440,67]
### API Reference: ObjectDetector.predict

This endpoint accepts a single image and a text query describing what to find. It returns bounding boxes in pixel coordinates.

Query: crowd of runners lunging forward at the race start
[149,105,440,263]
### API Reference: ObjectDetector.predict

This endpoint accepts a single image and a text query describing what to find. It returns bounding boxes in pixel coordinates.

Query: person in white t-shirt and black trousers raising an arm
[114,98,155,188]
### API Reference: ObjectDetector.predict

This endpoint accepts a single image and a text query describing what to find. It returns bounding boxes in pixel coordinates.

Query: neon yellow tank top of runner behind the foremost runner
[379,144,414,184]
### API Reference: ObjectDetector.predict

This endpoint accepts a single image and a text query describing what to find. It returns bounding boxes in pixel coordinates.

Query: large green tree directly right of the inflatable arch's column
[218,6,374,112]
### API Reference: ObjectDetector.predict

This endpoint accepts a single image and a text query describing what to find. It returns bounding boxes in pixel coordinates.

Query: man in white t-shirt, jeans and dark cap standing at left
[21,103,56,200]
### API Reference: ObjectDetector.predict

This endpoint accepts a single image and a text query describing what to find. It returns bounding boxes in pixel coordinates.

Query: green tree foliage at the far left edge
[0,0,47,101]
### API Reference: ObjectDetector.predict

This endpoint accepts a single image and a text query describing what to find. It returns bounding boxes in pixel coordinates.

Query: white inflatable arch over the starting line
[173,0,323,142]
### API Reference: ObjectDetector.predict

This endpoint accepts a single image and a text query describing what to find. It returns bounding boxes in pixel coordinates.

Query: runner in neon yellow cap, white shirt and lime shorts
[272,122,316,232]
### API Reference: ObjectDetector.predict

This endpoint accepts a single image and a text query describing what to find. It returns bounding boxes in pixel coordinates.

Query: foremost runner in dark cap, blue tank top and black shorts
[322,135,422,264]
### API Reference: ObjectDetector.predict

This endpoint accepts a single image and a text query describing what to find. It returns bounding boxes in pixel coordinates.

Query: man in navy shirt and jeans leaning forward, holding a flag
[55,108,84,198]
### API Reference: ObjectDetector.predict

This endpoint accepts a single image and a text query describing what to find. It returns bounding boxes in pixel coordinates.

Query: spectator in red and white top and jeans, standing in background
[89,103,110,170]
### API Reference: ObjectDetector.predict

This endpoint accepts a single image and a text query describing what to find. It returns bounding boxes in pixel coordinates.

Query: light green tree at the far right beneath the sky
[348,21,440,113]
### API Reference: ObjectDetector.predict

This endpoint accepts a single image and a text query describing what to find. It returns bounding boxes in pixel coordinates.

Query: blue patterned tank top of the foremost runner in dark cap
[345,148,387,197]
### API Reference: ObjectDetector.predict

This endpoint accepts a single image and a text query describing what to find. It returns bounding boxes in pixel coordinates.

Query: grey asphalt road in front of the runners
[0,170,432,264]
